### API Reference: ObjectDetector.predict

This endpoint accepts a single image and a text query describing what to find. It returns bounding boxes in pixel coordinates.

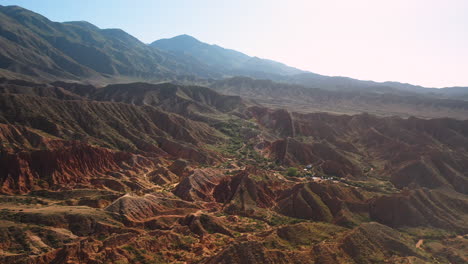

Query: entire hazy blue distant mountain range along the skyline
[0,6,468,99]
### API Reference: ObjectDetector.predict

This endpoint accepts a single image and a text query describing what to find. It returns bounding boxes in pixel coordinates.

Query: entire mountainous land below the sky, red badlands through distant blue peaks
[0,6,468,264]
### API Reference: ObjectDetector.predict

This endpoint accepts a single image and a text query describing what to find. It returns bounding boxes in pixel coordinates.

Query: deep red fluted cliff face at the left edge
[0,141,155,193]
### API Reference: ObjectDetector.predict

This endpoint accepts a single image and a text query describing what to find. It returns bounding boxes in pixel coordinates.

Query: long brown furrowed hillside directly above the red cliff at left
[0,94,220,153]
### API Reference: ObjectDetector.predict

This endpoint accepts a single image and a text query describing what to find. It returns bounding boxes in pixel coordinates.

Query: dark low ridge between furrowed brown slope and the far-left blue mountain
[0,78,250,120]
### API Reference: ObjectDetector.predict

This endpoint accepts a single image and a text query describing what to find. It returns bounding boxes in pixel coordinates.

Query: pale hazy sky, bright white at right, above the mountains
[0,0,468,87]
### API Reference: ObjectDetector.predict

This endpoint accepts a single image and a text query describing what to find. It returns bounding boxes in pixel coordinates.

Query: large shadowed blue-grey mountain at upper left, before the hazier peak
[0,6,214,79]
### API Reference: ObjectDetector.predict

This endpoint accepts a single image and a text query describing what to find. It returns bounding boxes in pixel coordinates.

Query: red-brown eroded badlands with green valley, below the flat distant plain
[0,80,468,263]
